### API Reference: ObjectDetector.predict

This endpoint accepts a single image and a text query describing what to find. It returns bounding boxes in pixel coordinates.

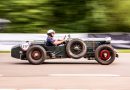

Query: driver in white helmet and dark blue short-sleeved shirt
[46,29,65,46]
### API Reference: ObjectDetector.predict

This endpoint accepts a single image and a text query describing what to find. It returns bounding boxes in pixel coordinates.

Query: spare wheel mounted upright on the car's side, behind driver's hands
[66,39,87,59]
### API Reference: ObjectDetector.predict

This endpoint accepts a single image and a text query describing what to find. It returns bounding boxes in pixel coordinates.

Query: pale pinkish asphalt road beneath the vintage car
[0,53,130,90]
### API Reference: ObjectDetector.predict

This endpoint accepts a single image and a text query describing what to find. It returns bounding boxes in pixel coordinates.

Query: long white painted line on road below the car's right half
[48,74,120,77]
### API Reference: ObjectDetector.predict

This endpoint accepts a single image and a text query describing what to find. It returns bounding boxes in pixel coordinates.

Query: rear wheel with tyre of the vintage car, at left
[26,45,46,65]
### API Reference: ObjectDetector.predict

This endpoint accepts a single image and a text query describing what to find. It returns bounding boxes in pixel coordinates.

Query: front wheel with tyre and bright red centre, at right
[95,45,116,65]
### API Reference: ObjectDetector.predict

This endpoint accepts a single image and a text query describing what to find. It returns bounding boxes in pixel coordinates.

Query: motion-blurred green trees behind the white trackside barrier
[0,0,130,33]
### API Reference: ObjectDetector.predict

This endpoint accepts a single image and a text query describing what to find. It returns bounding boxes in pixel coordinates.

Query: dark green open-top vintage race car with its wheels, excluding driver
[11,37,118,65]
